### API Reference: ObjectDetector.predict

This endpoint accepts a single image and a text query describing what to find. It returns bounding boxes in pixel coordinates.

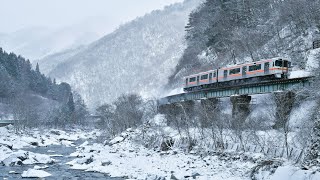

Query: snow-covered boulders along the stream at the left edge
[0,125,99,166]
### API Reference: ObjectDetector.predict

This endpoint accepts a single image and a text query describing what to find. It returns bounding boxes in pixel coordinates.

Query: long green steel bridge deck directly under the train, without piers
[159,77,312,105]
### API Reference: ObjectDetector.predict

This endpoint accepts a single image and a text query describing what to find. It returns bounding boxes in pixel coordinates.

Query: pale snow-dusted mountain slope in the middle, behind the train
[45,0,200,108]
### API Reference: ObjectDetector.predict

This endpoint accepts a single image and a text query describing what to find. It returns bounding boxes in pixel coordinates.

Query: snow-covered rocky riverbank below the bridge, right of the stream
[67,122,320,180]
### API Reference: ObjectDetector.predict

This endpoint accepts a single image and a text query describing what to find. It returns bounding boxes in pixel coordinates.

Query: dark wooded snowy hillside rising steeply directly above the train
[170,0,320,87]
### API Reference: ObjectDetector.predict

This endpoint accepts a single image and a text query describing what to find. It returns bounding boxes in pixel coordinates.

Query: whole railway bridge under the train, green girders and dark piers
[158,77,313,126]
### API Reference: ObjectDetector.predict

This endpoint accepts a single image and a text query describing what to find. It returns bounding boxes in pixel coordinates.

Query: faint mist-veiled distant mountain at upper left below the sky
[0,17,113,62]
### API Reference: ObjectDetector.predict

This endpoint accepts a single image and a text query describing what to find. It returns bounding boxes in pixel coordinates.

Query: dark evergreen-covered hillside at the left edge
[0,48,85,128]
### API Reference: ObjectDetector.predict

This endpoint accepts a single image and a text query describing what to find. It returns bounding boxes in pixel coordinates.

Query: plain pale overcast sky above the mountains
[0,0,183,33]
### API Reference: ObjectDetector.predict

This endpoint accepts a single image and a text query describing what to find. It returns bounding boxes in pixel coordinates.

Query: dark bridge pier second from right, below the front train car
[230,95,251,128]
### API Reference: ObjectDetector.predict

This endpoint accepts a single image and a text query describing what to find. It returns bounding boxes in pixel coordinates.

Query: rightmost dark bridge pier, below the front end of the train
[273,91,296,129]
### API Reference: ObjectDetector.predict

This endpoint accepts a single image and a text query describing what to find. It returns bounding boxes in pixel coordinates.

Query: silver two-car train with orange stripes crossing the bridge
[183,57,292,92]
